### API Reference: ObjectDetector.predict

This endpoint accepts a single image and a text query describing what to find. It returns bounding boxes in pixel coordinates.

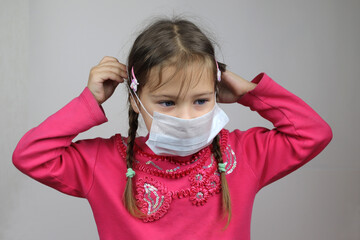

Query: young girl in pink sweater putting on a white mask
[13,19,332,240]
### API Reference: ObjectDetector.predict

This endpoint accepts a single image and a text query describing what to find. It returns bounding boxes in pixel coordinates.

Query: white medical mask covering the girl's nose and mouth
[131,89,229,157]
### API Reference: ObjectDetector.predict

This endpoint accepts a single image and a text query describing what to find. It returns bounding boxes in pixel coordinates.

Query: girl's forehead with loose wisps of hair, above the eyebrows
[144,63,215,97]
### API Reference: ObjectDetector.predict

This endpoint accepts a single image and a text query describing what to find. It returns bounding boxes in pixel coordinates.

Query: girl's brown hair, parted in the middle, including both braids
[124,18,231,227]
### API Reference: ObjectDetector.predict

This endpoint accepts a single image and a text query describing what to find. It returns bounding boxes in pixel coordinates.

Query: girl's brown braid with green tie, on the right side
[212,135,231,229]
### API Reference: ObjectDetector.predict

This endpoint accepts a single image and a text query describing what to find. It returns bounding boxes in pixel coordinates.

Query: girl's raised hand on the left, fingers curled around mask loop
[87,57,128,105]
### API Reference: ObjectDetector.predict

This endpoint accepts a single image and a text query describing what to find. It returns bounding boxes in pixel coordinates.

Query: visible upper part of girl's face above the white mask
[132,63,215,131]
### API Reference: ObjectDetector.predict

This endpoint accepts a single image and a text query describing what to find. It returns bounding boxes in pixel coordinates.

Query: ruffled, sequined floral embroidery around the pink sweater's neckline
[118,131,237,222]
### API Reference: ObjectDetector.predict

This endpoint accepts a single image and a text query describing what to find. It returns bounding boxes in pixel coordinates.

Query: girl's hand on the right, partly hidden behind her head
[218,70,257,103]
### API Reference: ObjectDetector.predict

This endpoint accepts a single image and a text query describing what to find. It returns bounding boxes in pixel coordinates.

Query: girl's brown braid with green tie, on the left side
[123,107,142,217]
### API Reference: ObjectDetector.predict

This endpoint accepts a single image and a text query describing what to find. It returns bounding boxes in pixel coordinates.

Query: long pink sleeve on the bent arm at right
[235,73,332,190]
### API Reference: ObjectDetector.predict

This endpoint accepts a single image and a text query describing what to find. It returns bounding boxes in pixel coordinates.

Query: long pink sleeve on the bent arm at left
[13,87,108,197]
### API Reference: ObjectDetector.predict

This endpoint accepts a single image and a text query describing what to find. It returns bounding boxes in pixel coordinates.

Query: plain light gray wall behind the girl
[0,0,360,240]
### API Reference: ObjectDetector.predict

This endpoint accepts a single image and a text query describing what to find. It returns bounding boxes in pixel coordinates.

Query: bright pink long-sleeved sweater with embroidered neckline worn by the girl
[13,73,332,240]
